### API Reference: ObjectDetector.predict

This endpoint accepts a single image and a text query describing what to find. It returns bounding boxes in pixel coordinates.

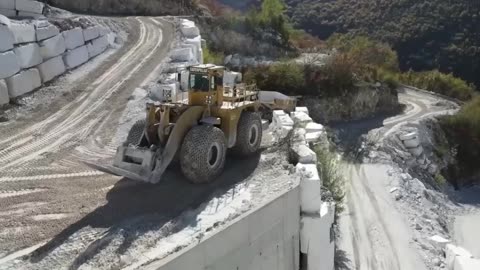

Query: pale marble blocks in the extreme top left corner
[0,0,45,19]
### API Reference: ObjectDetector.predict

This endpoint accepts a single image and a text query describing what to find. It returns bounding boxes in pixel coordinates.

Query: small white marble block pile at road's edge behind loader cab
[170,19,203,65]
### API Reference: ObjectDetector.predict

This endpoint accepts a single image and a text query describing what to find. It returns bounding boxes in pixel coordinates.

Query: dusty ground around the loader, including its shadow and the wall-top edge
[0,15,298,269]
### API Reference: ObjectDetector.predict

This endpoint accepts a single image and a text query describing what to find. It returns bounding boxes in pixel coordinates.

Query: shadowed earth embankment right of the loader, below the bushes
[300,84,401,123]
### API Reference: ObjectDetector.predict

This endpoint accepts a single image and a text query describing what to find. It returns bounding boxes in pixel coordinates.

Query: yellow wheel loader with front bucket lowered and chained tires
[89,64,296,183]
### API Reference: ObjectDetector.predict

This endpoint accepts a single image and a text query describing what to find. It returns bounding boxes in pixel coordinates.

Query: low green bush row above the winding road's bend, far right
[400,70,475,101]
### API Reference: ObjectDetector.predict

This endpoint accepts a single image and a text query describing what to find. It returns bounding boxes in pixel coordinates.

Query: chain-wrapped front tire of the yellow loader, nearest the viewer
[180,125,227,184]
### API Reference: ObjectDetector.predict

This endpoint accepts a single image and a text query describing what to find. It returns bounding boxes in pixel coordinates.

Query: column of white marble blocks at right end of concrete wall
[272,107,335,270]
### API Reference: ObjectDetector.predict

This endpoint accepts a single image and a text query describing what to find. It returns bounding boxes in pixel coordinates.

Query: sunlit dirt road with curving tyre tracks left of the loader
[0,17,174,258]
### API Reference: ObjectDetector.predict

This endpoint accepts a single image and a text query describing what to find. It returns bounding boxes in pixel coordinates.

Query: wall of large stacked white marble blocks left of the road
[0,15,109,105]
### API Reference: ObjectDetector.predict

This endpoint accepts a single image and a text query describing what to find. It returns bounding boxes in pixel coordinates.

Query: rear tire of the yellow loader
[232,112,263,156]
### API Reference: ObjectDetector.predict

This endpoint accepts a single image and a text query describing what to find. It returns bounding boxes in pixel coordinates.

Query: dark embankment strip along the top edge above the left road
[46,0,195,16]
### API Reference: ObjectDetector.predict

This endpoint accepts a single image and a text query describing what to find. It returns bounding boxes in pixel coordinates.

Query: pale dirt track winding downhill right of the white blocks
[337,89,452,270]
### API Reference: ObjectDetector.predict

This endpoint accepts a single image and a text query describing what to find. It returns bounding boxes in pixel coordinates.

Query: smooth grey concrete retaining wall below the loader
[144,185,300,270]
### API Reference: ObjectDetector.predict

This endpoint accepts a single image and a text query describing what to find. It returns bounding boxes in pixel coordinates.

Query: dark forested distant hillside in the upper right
[218,0,480,86]
